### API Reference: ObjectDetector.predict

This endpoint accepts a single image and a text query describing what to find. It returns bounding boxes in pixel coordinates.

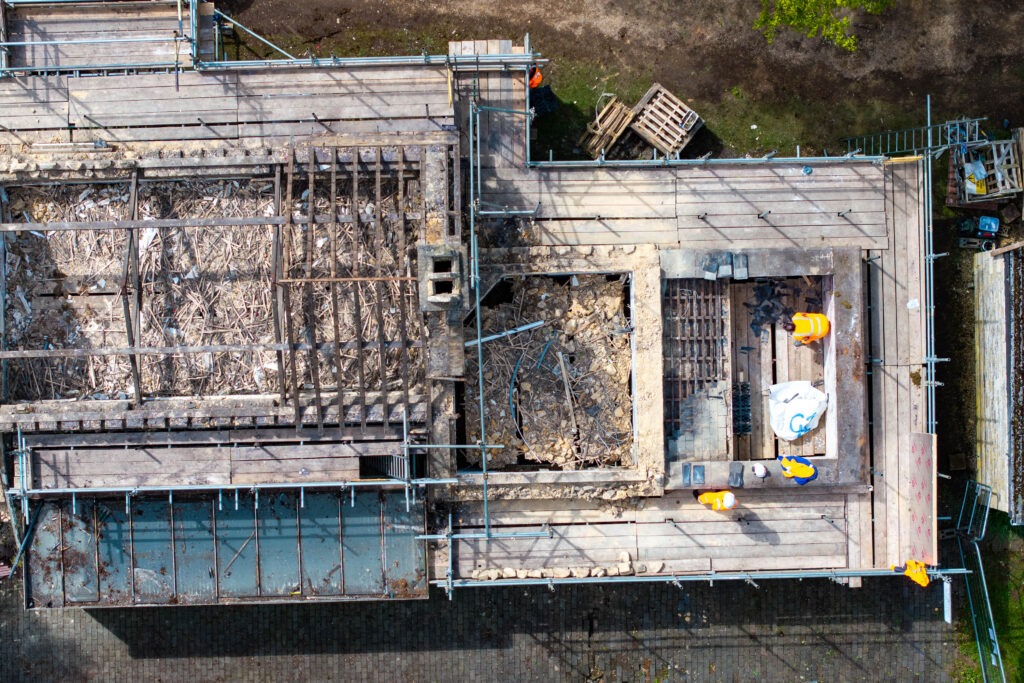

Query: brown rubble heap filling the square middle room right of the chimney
[465,275,633,470]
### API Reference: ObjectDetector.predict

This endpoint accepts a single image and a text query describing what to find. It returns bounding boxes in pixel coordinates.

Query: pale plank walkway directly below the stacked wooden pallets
[481,164,888,249]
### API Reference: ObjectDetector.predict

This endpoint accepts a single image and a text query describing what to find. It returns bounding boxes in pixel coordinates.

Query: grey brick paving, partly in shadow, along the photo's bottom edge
[0,579,959,683]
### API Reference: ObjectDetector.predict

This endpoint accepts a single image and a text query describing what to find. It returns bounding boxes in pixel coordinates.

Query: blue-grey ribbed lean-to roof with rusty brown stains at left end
[25,490,427,608]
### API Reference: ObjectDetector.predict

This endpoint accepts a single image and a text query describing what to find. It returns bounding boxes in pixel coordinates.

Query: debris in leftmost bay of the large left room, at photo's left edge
[4,184,133,400]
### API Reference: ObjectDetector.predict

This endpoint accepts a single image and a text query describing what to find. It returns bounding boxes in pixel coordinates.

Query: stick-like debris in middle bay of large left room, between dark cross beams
[138,180,276,396]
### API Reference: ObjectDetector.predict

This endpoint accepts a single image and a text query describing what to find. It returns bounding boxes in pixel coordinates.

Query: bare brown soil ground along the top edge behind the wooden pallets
[226,0,1024,152]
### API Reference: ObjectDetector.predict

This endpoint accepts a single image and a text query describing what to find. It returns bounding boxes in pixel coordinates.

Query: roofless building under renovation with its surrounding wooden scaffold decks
[0,0,938,608]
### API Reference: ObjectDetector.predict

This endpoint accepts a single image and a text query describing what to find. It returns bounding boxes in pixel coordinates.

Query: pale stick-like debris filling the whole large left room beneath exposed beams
[5,178,422,400]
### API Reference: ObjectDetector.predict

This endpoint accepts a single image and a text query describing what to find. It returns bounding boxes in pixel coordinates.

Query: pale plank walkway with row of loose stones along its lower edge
[456,490,847,577]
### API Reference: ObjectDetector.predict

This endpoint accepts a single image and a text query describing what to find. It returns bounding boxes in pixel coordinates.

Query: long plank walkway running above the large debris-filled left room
[0,67,454,143]
